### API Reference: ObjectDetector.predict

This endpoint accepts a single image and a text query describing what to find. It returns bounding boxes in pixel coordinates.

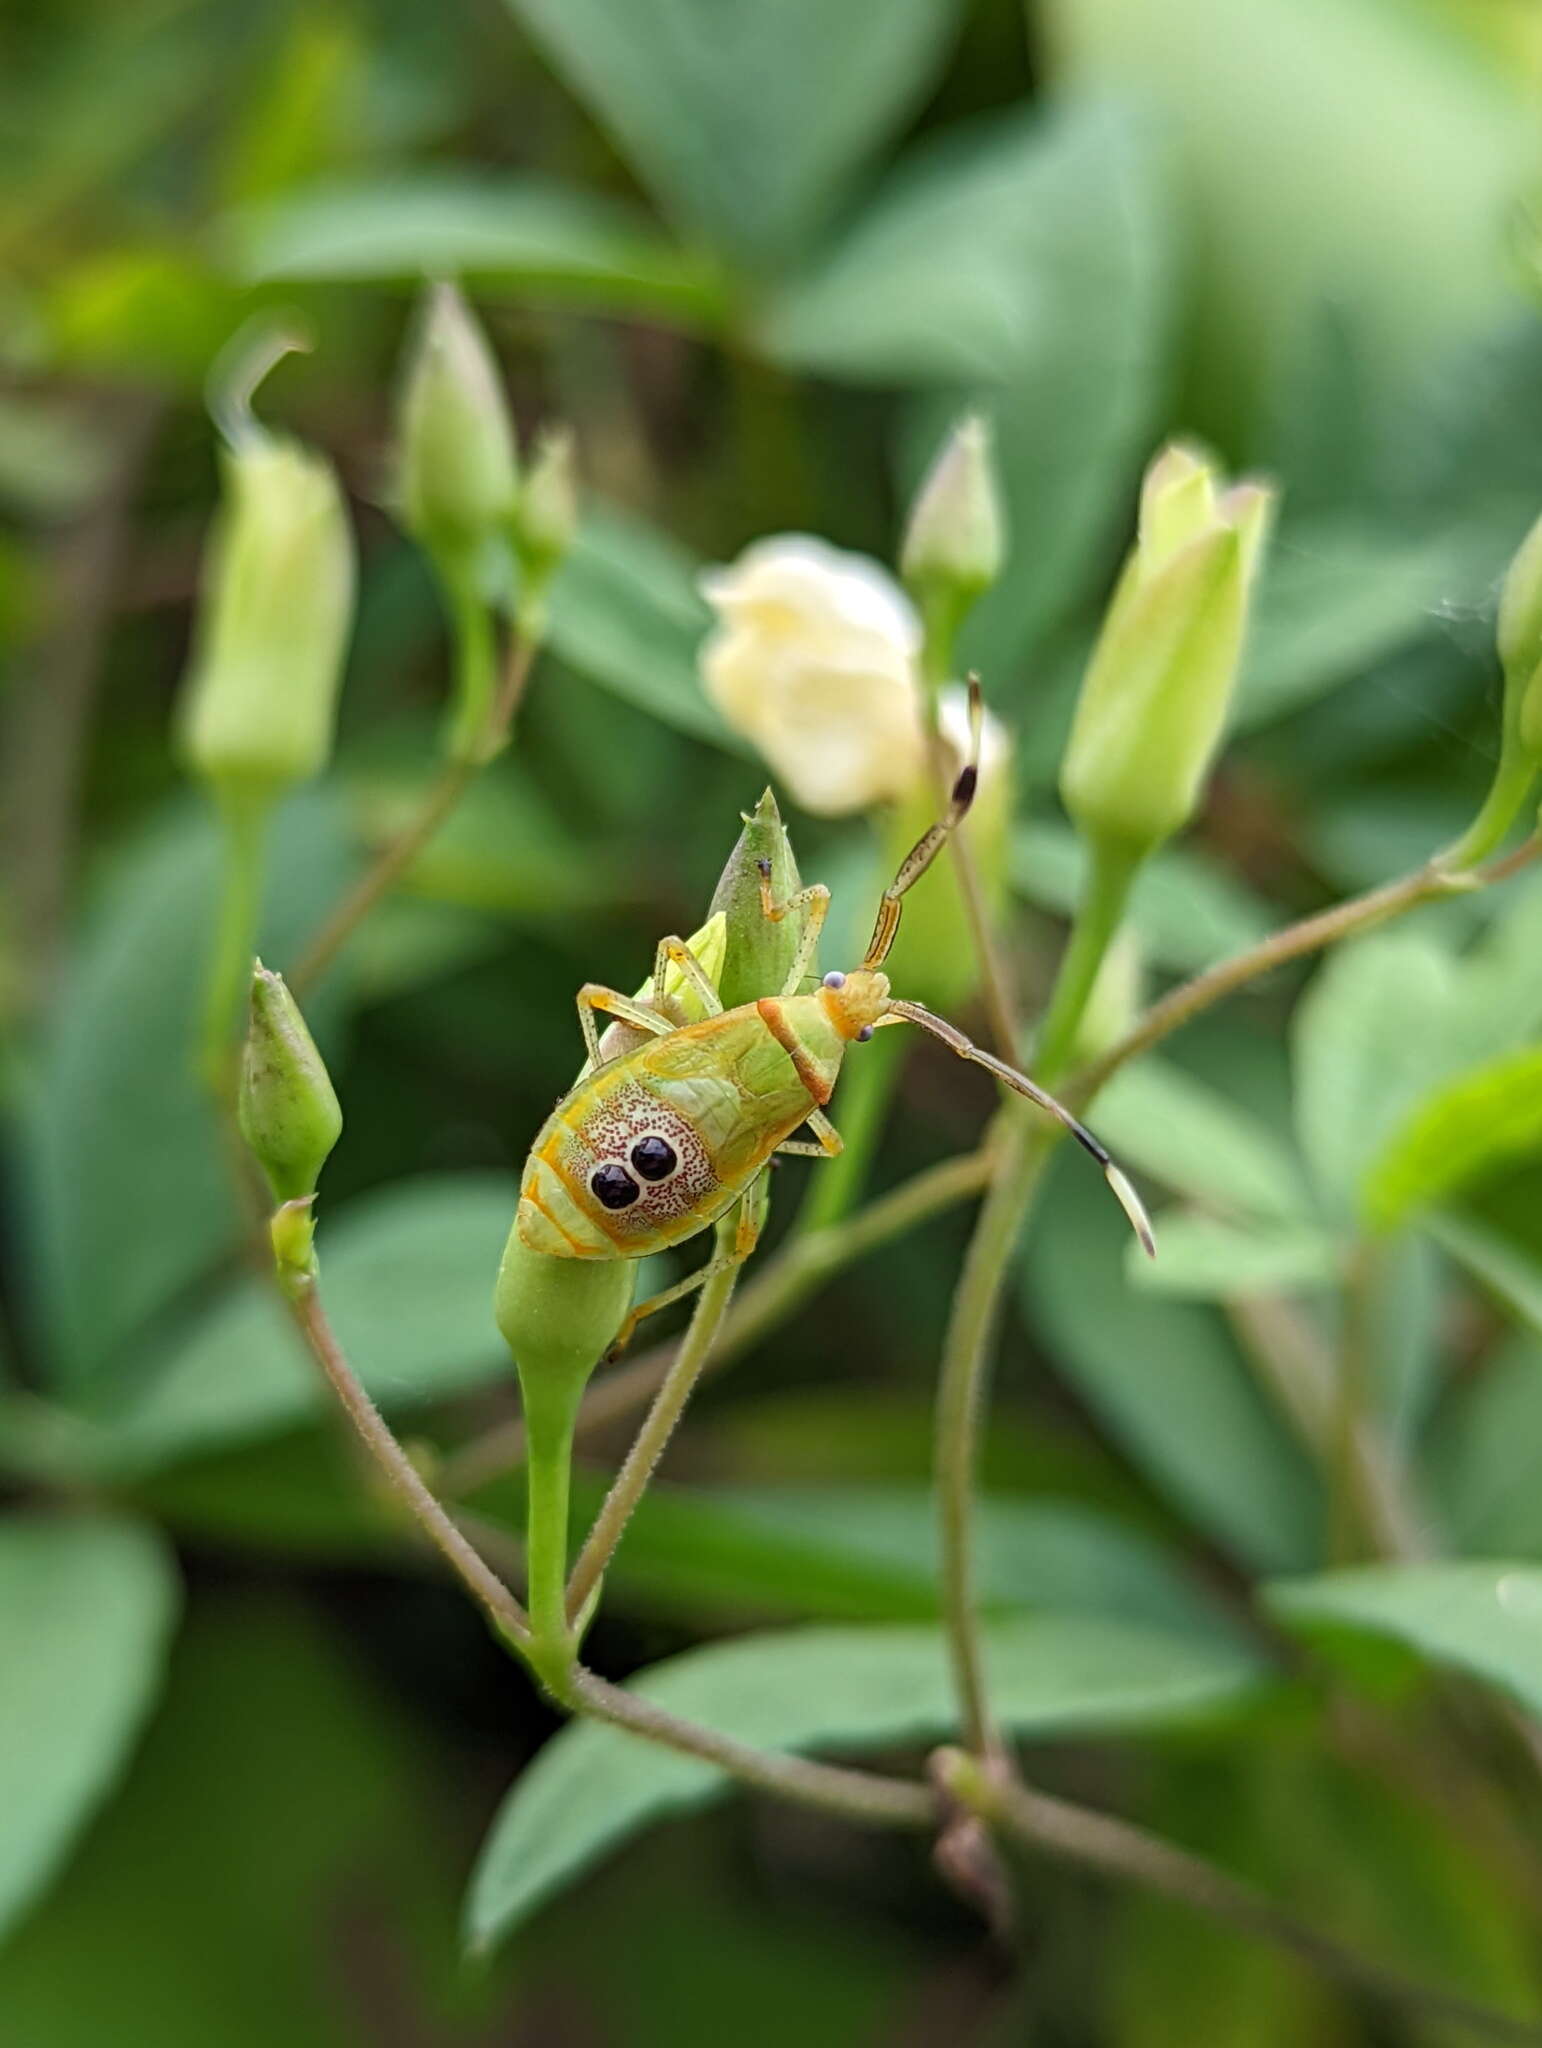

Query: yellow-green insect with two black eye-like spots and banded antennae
[516,686,1155,1341]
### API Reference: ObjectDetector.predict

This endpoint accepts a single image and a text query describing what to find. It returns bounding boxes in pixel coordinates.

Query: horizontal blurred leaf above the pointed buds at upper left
[219,168,723,326]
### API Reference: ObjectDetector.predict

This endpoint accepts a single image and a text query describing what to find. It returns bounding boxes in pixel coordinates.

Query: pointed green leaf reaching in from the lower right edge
[1263,1559,1542,1720]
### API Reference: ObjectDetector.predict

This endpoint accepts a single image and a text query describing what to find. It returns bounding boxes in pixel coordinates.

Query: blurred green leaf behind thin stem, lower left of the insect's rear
[99,1174,514,1470]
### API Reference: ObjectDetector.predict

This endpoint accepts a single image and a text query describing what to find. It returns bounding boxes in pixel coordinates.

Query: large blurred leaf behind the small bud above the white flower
[762,104,1169,678]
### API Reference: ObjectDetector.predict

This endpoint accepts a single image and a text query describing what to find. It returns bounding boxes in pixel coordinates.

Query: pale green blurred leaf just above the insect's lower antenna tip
[1096,1055,1311,1220]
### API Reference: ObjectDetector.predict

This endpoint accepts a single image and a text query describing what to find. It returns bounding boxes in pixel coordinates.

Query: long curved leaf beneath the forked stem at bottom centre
[467,1616,1257,1950]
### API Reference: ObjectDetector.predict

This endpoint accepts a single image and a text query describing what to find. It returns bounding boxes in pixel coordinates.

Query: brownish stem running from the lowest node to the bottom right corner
[936,1751,1542,2044]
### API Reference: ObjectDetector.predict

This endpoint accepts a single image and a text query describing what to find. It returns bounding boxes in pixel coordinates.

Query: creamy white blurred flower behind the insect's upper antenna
[700,532,926,815]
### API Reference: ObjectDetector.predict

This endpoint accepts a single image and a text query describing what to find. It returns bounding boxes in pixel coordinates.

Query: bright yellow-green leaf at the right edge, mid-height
[1362,1044,1542,1231]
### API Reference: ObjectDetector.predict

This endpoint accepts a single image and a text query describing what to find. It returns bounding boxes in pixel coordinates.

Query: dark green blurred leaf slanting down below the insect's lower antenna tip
[1020,1161,1323,1571]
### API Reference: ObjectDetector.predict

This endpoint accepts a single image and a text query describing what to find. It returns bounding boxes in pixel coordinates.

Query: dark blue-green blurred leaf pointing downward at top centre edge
[499,0,954,270]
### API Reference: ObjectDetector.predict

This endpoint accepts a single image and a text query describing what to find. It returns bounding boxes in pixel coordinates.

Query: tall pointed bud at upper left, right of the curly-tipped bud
[397,285,518,565]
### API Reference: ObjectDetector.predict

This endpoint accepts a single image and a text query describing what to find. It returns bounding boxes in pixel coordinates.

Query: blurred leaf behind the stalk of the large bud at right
[1012,819,1276,975]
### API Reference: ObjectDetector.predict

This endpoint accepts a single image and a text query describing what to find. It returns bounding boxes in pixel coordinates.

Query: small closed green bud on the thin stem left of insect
[238,961,342,1202]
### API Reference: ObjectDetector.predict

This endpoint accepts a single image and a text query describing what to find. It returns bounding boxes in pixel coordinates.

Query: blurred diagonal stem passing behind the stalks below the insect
[440,1149,991,1499]
